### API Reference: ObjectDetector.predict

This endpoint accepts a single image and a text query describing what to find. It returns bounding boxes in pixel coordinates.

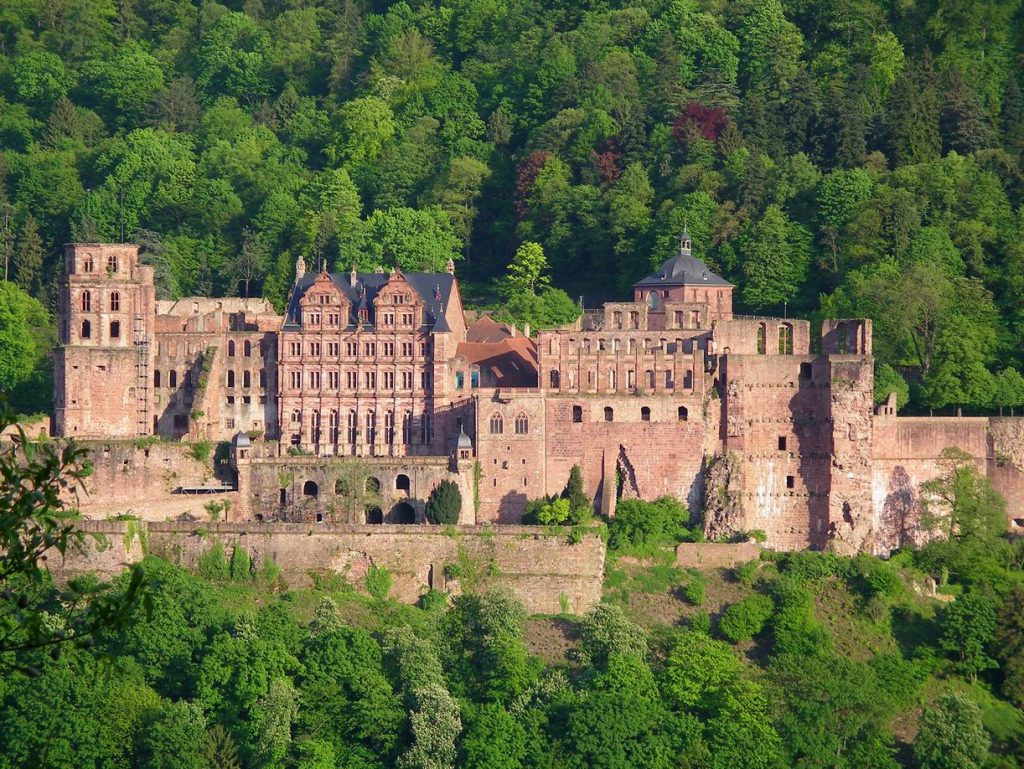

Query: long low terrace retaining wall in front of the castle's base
[48,521,605,613]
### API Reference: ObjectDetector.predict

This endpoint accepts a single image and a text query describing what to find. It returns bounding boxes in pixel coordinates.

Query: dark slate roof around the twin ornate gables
[285,272,455,332]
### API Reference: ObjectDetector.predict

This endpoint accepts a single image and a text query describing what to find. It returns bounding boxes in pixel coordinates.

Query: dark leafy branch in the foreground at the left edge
[0,410,148,674]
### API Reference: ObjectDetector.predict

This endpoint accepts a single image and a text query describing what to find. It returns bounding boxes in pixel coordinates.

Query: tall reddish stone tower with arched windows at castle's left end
[53,243,156,438]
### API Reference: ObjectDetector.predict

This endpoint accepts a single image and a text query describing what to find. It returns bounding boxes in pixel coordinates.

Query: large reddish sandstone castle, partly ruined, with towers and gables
[53,233,1024,552]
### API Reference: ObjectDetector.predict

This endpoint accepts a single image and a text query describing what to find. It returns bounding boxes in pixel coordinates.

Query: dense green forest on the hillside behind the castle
[0,0,1024,412]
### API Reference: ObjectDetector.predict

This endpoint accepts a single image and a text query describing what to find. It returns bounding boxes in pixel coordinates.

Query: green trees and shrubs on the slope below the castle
[6,447,1024,769]
